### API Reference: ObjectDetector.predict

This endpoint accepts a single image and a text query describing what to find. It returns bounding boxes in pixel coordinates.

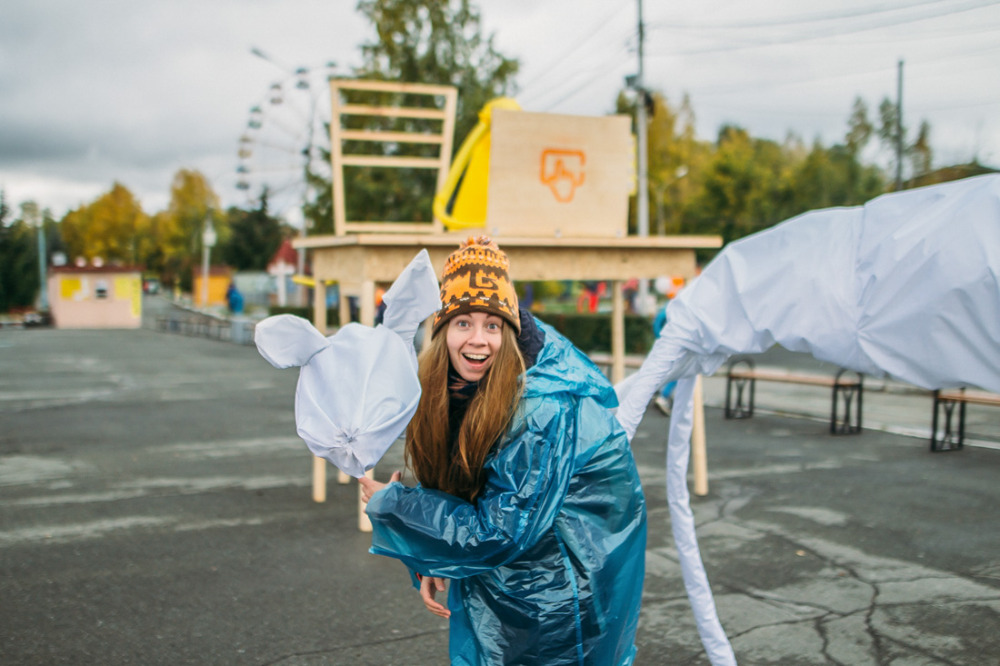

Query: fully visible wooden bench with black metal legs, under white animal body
[726,359,864,435]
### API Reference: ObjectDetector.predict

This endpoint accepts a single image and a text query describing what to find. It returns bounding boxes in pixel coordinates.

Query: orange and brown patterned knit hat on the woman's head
[434,236,521,334]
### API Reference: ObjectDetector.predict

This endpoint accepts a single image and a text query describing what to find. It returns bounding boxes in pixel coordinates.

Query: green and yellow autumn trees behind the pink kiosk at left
[0,169,294,312]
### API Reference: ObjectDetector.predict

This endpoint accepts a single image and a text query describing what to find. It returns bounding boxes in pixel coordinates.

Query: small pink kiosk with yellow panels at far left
[48,266,142,328]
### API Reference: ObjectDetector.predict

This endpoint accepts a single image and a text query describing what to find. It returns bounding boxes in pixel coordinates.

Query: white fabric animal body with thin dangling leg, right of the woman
[615,175,1000,665]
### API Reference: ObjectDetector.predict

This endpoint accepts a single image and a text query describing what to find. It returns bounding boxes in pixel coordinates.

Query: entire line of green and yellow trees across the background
[0,0,990,311]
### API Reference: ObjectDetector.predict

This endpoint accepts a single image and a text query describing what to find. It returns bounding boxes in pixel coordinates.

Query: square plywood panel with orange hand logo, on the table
[486,109,633,238]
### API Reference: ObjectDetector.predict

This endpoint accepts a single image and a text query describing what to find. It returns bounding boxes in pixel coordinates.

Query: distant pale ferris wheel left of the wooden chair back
[236,57,335,231]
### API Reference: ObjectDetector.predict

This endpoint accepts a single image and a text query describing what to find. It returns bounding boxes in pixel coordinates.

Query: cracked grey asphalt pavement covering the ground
[0,312,1000,666]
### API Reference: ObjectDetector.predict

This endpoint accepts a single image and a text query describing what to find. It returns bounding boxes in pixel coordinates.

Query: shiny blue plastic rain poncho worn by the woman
[367,323,646,666]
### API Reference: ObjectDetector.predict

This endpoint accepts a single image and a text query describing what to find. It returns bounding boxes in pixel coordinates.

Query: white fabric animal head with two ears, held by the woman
[254,250,441,477]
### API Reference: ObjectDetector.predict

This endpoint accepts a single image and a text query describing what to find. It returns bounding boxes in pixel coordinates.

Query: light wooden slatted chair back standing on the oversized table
[330,79,458,236]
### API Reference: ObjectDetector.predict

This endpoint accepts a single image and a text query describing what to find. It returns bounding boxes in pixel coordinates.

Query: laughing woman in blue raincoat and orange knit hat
[360,237,646,666]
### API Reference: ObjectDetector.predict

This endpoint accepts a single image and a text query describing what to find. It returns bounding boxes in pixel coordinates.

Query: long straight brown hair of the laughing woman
[406,322,524,502]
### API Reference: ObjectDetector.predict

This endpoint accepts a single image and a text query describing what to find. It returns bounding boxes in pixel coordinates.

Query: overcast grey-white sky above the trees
[0,0,1000,223]
